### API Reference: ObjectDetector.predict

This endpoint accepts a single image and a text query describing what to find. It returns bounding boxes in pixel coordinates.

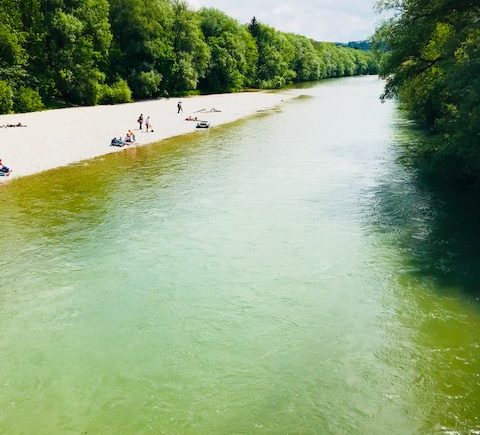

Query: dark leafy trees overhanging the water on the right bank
[374,0,480,183]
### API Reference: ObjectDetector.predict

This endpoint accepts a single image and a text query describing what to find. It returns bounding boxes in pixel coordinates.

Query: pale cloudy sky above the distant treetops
[188,0,379,42]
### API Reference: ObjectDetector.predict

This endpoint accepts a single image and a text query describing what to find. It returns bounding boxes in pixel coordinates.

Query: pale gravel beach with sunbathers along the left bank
[0,92,293,181]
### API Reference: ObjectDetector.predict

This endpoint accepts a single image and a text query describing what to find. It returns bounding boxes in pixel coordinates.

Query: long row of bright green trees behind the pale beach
[0,0,377,113]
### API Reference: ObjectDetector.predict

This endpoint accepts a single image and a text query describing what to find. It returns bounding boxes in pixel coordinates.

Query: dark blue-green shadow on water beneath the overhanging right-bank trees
[373,116,480,300]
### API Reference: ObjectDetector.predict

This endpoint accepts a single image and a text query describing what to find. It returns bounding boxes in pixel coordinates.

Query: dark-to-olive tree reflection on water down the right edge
[368,119,480,433]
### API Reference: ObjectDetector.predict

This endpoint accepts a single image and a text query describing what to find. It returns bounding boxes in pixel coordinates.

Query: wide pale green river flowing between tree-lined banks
[0,77,480,434]
